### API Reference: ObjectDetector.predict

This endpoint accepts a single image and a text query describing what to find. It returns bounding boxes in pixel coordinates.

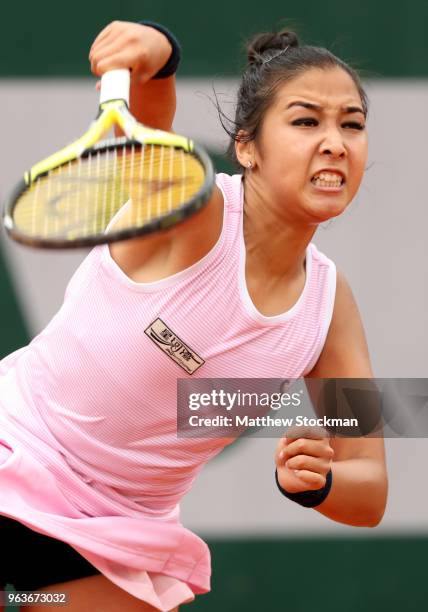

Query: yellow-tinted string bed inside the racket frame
[14,145,205,240]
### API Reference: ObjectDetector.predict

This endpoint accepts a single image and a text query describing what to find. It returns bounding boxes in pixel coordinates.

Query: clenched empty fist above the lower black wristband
[275,428,334,493]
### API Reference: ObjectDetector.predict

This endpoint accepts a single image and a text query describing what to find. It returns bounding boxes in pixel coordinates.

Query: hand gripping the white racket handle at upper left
[89,21,172,83]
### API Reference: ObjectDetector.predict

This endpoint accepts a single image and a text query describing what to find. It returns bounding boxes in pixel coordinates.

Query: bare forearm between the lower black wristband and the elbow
[314,458,388,527]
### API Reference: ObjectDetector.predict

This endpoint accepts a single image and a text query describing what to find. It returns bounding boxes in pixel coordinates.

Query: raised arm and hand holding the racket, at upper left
[89,21,176,131]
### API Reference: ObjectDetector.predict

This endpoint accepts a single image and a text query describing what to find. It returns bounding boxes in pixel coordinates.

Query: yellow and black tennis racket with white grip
[3,70,214,248]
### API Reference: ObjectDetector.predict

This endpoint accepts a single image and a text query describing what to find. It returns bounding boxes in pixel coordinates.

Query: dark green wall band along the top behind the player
[0,0,428,77]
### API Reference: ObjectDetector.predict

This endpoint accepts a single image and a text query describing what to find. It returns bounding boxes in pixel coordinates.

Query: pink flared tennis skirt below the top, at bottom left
[0,438,210,611]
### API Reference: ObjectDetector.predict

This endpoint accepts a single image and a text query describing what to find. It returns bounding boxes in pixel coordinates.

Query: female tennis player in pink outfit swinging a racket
[0,22,387,612]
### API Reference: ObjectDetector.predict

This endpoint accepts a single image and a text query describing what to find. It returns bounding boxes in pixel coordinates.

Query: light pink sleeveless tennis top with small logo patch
[0,174,336,590]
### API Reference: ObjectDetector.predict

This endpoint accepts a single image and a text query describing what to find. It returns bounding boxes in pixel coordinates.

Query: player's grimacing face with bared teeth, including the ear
[237,67,367,223]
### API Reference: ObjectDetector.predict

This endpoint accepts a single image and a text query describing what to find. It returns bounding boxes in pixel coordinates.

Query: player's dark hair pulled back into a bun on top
[217,30,368,166]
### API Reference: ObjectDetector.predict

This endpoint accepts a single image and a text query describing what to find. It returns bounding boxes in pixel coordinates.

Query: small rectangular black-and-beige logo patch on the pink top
[144,319,205,374]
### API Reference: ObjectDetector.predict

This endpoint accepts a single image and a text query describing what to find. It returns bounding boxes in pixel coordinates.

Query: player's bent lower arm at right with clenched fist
[276,274,387,527]
